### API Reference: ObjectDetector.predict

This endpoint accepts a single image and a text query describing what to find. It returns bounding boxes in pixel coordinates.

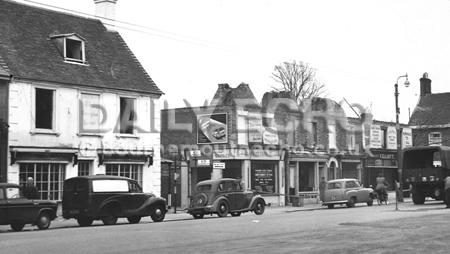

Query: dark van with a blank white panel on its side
[62,175,167,226]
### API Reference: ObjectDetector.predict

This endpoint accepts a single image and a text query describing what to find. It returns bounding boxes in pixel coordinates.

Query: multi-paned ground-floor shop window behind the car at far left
[19,163,66,200]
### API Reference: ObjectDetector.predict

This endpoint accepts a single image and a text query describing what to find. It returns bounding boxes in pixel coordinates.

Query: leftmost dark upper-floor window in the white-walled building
[35,88,55,130]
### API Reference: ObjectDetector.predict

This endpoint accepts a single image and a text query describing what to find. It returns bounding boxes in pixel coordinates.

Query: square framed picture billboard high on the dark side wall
[197,113,228,144]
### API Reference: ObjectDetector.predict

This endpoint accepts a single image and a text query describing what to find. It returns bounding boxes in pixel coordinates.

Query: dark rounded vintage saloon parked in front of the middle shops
[187,178,266,219]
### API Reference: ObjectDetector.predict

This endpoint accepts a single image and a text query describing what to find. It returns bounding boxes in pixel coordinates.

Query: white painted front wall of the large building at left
[8,80,161,195]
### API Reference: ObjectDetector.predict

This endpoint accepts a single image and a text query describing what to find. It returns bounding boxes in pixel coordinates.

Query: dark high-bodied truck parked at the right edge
[403,146,450,204]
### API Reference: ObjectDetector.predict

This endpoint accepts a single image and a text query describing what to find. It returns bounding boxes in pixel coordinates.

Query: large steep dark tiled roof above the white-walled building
[0,0,162,95]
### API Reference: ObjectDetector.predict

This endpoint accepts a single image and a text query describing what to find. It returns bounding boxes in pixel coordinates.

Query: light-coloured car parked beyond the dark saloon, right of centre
[322,179,375,208]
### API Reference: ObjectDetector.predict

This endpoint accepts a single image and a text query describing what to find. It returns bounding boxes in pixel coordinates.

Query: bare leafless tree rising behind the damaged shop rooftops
[272,60,325,103]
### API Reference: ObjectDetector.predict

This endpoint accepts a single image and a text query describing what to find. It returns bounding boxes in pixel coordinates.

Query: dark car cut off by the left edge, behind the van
[0,183,57,231]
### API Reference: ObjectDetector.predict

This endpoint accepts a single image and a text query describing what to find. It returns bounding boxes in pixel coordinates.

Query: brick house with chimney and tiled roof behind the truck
[409,73,450,146]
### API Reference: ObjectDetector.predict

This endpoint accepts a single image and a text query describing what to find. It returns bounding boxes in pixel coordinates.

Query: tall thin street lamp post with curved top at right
[394,74,409,202]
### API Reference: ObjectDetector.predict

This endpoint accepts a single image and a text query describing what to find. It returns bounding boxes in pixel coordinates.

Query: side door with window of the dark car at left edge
[5,187,40,223]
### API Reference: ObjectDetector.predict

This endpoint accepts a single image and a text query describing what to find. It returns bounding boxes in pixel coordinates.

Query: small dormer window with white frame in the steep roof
[50,34,86,63]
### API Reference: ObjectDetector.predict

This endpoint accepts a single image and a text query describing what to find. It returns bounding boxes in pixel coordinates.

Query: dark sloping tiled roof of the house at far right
[409,93,450,126]
